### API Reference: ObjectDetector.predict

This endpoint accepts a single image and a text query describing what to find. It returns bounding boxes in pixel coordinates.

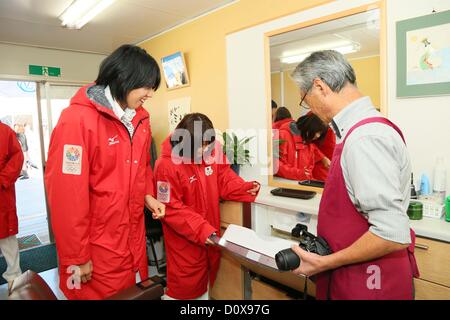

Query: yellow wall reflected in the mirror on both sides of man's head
[272,56,380,119]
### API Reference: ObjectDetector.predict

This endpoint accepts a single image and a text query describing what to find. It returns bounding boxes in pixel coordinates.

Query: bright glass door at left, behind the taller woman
[0,80,83,250]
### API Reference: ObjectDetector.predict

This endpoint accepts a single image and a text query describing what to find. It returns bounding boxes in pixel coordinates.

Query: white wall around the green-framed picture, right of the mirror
[387,0,450,194]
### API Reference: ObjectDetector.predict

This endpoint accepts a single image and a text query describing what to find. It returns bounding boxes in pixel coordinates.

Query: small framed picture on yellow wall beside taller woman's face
[161,51,189,90]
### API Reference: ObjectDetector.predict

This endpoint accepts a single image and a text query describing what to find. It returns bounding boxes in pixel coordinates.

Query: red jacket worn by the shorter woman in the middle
[155,138,255,299]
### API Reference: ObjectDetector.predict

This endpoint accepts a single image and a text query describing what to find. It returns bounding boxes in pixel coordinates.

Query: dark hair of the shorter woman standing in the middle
[170,113,216,161]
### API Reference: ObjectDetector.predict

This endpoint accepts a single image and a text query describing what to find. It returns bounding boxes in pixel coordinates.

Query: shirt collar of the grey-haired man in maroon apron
[331,97,376,142]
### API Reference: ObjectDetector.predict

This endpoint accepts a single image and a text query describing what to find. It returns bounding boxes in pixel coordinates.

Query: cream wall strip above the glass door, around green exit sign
[0,43,106,82]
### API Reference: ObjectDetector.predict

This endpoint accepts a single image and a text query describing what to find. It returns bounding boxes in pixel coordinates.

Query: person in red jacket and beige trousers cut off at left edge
[0,122,23,288]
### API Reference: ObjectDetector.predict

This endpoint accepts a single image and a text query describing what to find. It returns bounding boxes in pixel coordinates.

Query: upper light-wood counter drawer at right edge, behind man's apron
[414,237,450,287]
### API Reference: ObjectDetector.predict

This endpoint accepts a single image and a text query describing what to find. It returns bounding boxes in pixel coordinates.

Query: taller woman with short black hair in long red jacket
[45,45,164,299]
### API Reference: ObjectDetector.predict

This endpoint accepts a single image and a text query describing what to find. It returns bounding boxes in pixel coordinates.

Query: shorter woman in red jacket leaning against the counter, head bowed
[155,113,259,299]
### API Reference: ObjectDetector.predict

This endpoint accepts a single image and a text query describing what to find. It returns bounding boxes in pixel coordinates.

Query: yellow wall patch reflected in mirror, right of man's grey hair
[349,56,380,109]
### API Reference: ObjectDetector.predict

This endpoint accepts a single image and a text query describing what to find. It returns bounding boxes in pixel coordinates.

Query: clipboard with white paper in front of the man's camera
[214,224,297,271]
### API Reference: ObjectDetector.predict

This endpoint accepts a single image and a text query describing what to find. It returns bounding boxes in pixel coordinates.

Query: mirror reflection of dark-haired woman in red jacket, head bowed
[275,115,330,180]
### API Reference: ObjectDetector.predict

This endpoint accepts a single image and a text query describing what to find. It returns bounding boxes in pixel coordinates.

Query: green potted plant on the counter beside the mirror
[222,132,254,175]
